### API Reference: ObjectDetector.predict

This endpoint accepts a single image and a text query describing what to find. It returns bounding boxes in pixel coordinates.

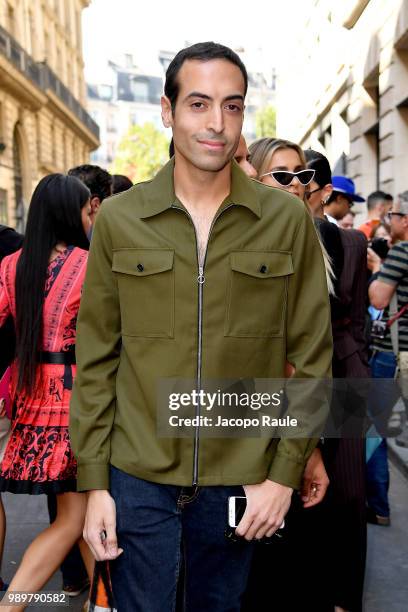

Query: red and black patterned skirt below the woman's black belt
[0,364,77,495]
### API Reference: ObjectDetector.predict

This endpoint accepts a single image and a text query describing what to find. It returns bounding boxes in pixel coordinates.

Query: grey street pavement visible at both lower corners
[3,464,408,612]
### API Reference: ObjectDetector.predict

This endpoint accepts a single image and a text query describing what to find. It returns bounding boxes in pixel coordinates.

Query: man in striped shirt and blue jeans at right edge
[367,191,408,526]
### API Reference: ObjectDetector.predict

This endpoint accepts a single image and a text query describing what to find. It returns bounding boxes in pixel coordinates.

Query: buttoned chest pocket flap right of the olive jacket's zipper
[231,251,293,278]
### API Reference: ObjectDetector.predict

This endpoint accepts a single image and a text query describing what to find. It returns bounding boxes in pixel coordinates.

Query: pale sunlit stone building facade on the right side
[277,0,408,203]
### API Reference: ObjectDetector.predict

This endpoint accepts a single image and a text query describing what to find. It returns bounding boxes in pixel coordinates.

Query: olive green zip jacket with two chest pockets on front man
[70,160,332,490]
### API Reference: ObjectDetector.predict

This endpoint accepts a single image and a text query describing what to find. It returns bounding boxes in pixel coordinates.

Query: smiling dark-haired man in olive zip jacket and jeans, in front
[70,43,332,612]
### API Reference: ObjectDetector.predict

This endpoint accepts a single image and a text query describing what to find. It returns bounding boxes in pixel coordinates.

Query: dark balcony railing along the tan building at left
[0,26,99,139]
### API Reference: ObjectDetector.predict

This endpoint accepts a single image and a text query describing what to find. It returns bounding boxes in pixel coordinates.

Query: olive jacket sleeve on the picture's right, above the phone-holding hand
[268,209,333,489]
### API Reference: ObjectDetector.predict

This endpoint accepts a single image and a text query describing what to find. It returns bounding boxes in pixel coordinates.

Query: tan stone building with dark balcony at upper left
[0,0,99,231]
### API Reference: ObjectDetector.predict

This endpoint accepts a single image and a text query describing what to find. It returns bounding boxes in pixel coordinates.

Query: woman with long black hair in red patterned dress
[0,174,92,611]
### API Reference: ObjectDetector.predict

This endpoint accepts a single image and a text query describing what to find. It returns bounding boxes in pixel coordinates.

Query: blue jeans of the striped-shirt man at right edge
[366,351,398,516]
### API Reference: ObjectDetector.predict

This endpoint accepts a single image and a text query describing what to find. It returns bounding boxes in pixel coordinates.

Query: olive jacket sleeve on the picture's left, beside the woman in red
[70,207,121,491]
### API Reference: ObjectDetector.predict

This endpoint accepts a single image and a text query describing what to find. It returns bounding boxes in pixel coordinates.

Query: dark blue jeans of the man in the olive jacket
[111,467,254,612]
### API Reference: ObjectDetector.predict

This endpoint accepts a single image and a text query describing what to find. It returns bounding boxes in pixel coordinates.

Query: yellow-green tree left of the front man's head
[112,123,169,183]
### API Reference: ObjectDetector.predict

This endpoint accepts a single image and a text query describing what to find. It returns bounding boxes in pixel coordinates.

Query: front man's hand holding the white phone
[235,480,293,540]
